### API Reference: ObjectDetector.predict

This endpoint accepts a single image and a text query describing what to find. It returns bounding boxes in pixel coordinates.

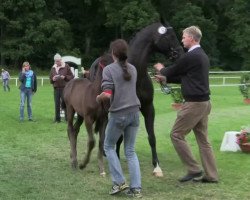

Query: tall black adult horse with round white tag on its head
[90,21,184,177]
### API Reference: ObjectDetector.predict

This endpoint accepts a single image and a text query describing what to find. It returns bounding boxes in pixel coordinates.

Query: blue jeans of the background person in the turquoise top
[20,88,33,120]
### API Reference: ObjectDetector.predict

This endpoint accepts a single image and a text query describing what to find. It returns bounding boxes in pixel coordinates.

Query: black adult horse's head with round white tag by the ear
[153,23,184,60]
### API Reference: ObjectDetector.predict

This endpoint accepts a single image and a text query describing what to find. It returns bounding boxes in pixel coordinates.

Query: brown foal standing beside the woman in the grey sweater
[63,54,113,176]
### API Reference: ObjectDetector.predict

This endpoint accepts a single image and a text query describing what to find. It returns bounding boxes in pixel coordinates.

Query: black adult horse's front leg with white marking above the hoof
[141,103,163,177]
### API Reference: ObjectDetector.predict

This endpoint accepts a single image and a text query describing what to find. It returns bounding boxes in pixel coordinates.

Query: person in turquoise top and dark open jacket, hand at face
[19,61,37,122]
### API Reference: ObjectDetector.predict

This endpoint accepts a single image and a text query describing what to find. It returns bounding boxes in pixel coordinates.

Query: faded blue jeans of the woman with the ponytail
[104,111,141,188]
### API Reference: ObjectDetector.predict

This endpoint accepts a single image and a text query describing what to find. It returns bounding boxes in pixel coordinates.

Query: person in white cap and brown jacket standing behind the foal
[49,53,74,123]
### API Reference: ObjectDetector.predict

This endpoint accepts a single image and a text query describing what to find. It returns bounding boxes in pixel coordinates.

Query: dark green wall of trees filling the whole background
[0,0,250,70]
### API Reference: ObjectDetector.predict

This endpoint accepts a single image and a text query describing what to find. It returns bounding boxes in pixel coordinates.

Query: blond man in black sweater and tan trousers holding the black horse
[154,26,218,183]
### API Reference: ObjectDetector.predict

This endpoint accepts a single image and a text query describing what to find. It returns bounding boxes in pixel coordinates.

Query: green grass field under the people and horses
[0,84,250,200]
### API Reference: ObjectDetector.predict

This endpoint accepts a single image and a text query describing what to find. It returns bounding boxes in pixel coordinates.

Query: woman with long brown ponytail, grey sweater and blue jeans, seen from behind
[97,39,142,197]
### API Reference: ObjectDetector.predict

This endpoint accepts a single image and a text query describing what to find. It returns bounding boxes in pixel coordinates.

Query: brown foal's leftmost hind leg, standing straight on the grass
[67,106,78,169]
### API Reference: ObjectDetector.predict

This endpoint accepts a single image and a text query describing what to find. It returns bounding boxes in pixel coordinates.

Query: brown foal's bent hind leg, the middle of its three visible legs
[79,117,95,169]
